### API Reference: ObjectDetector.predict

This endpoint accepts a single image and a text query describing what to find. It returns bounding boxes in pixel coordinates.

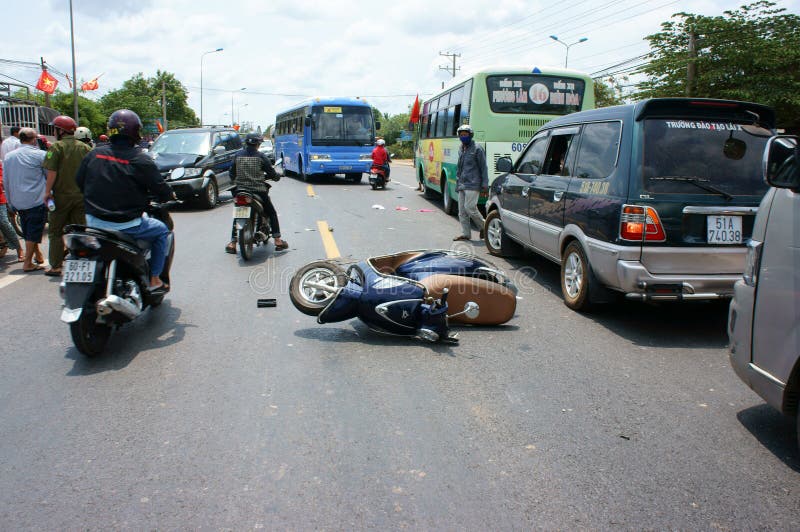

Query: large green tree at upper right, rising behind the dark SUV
[637,0,800,128]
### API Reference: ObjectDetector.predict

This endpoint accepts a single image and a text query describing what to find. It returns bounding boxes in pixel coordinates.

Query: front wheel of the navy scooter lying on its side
[289,260,347,316]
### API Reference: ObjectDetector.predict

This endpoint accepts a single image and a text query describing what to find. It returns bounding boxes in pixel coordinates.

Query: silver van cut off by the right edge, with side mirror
[728,135,800,442]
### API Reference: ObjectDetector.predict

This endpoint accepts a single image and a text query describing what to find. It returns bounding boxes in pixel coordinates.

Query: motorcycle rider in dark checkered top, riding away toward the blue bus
[225,133,289,254]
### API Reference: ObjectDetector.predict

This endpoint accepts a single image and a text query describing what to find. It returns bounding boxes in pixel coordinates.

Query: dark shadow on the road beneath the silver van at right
[736,404,800,473]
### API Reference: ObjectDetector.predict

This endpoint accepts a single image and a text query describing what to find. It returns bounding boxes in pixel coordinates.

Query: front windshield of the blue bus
[311,105,374,146]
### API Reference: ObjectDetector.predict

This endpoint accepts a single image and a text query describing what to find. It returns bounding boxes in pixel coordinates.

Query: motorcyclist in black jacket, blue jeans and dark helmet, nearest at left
[75,109,175,291]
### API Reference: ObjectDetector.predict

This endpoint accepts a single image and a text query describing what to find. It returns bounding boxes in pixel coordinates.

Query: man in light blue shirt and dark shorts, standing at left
[3,127,47,273]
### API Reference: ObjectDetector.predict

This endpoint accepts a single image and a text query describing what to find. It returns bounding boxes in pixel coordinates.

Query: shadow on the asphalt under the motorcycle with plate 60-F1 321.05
[65,299,197,377]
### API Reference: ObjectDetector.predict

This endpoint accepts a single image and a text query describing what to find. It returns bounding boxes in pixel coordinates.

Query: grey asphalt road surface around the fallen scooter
[0,163,800,530]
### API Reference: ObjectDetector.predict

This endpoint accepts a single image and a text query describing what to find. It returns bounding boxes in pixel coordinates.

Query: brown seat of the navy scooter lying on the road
[420,273,517,325]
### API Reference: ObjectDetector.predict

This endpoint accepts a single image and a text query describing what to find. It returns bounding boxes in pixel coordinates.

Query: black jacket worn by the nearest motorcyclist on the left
[75,139,172,222]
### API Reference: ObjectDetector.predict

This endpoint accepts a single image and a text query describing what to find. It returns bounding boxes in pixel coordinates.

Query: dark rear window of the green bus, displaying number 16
[486,74,585,115]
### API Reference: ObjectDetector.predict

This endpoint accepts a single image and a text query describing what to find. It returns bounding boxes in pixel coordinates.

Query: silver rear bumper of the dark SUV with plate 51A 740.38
[617,260,742,301]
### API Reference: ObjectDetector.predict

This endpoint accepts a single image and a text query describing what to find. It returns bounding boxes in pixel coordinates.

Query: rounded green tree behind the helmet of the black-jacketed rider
[100,70,199,128]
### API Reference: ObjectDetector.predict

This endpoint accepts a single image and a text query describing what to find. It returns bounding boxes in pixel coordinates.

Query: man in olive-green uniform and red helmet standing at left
[43,115,91,277]
